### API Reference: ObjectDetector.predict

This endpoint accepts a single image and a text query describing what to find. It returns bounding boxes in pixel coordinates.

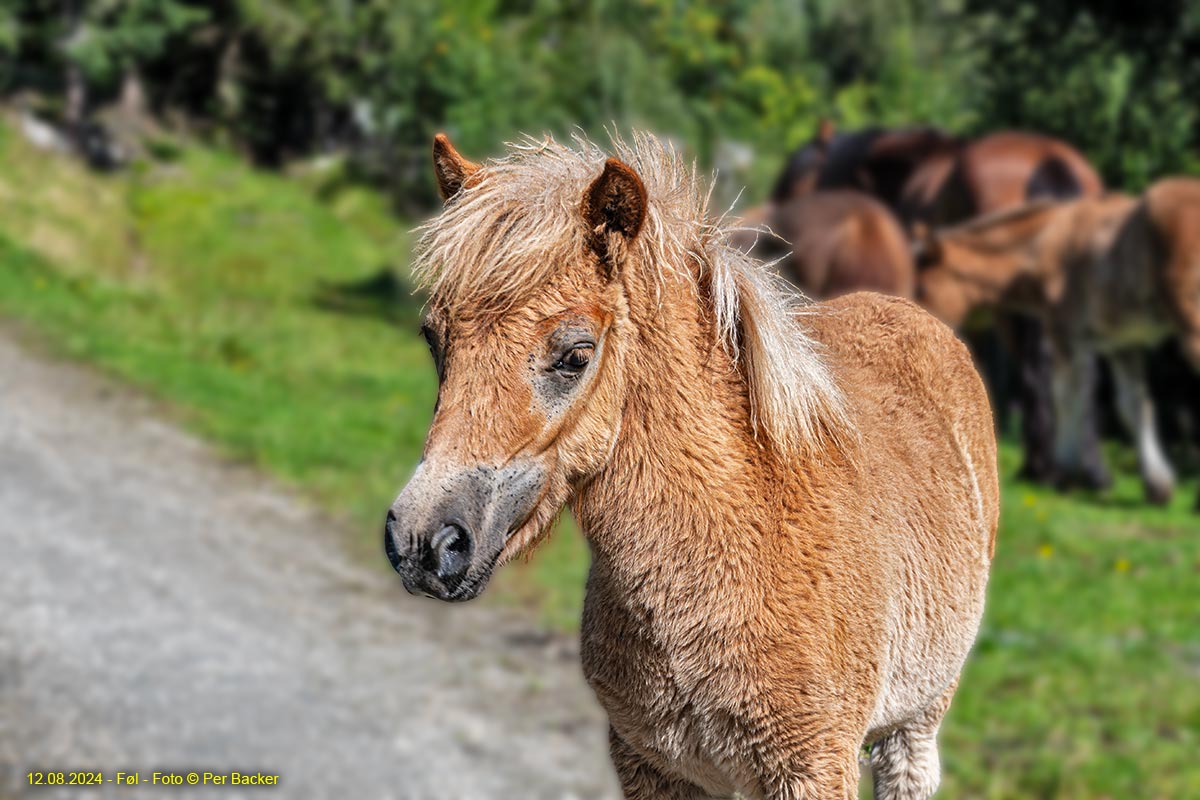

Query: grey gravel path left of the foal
[0,336,616,800]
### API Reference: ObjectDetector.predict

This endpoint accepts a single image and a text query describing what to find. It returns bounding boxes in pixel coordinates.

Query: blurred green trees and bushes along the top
[0,0,1200,199]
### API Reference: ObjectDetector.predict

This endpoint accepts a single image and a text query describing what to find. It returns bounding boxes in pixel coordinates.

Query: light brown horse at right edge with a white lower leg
[918,178,1200,503]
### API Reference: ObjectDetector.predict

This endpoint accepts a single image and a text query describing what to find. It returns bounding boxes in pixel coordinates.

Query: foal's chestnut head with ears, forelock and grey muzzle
[385,136,647,600]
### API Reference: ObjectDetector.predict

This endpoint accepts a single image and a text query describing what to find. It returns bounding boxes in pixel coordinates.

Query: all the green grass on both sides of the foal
[0,120,1200,800]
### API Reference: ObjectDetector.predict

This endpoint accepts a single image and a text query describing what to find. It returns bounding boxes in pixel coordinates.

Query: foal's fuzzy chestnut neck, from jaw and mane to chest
[572,267,773,591]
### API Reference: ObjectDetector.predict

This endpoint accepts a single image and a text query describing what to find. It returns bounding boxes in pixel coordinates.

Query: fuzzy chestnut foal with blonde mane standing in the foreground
[388,137,998,800]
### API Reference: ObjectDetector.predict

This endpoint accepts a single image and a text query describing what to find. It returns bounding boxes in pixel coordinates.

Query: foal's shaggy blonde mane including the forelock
[414,133,852,453]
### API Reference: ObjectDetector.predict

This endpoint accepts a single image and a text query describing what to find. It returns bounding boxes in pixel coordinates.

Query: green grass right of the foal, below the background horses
[942,446,1200,799]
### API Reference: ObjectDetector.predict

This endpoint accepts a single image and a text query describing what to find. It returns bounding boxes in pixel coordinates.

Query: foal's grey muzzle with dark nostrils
[383,462,545,601]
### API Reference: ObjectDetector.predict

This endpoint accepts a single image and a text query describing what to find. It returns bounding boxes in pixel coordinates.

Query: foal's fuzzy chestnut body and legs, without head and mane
[574,295,998,800]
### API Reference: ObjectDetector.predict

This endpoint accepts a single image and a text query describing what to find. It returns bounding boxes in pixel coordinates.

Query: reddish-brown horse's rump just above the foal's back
[734,190,916,299]
